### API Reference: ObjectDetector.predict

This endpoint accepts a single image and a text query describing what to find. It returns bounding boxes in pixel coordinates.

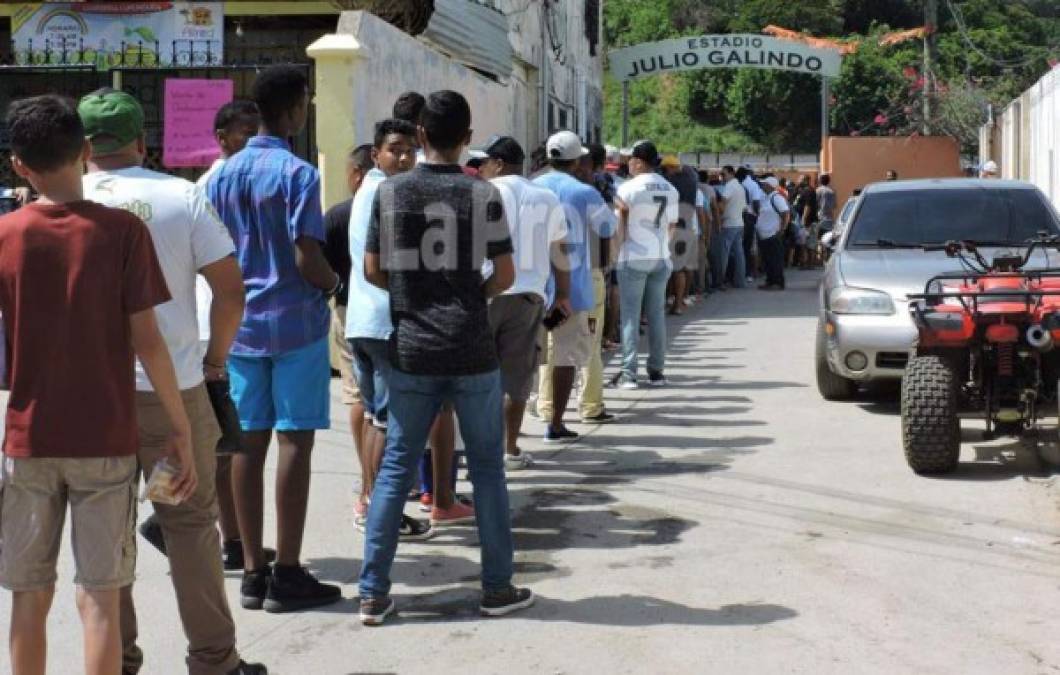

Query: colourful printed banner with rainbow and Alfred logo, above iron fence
[11,0,225,69]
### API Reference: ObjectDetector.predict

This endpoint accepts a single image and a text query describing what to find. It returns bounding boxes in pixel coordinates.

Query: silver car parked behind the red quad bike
[815,179,1060,401]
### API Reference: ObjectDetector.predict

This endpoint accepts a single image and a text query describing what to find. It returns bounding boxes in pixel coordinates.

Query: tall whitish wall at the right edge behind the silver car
[979,69,1060,209]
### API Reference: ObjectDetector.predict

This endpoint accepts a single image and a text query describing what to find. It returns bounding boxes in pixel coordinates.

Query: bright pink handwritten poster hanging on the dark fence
[162,78,233,168]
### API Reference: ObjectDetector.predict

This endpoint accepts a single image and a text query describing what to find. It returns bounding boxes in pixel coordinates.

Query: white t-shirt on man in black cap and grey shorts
[483,176,567,302]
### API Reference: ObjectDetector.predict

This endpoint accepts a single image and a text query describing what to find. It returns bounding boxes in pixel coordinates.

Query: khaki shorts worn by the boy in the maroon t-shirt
[0,455,137,591]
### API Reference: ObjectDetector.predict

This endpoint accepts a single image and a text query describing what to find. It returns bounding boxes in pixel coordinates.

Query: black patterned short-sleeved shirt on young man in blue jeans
[365,164,512,375]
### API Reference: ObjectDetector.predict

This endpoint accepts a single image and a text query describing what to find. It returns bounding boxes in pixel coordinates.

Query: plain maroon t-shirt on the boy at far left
[0,201,170,458]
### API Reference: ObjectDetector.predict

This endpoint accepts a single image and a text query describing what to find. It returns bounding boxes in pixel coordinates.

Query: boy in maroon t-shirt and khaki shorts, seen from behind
[0,95,197,675]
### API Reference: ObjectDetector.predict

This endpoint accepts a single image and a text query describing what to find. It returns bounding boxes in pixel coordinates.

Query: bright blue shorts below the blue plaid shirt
[228,336,331,431]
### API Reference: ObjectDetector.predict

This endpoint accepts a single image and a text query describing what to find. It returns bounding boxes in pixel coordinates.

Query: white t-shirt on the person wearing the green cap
[84,166,235,391]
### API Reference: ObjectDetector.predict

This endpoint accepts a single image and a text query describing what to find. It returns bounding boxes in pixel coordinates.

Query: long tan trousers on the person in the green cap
[122,385,240,675]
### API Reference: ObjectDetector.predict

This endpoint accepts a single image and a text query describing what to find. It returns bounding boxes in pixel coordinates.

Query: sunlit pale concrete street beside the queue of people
[0,272,1060,675]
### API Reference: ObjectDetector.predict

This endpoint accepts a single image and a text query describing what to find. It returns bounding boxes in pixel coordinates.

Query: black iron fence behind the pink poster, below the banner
[0,40,317,185]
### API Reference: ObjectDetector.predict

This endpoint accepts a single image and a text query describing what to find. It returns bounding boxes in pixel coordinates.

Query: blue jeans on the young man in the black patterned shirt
[360,369,513,598]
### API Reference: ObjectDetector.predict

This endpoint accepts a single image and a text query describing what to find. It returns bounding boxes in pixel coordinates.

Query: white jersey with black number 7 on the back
[618,174,681,263]
